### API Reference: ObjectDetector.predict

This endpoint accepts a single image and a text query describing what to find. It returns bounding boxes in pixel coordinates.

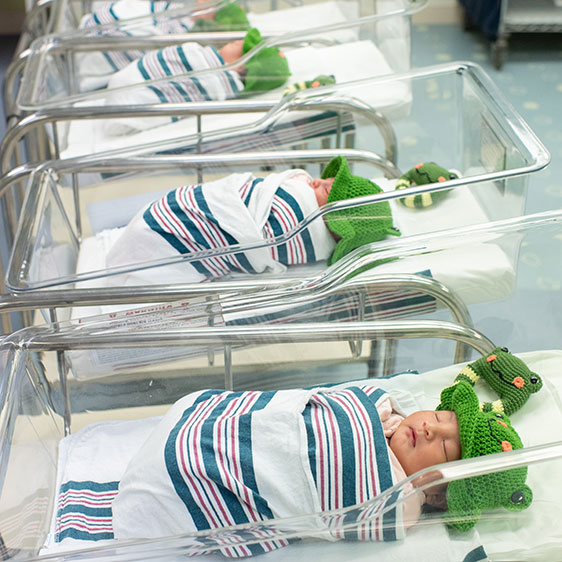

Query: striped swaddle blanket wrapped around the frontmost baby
[113,386,403,556]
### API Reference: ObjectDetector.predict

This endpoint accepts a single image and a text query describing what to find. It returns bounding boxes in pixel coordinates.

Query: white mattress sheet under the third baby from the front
[61,41,411,158]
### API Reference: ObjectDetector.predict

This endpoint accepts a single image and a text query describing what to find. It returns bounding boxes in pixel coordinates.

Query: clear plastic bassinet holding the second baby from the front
[2,70,549,291]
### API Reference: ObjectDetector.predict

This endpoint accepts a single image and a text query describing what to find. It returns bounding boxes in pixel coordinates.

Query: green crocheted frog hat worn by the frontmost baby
[437,380,533,531]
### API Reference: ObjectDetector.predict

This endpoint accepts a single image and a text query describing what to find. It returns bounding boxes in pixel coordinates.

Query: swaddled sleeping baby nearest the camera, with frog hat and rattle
[53,348,542,557]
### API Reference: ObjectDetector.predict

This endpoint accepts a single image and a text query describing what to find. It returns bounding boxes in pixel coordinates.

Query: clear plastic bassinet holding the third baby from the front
[8,0,425,113]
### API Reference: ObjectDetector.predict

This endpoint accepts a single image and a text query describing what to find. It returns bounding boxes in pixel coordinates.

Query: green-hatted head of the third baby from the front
[219,28,291,93]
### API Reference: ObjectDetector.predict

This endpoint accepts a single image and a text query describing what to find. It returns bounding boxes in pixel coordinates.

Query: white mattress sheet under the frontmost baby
[42,373,481,562]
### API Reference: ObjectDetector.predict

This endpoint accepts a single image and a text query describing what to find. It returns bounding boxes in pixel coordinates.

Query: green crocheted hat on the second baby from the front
[322,156,400,265]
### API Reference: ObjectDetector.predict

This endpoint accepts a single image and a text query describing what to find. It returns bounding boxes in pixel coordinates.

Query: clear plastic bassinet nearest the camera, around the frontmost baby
[0,233,562,561]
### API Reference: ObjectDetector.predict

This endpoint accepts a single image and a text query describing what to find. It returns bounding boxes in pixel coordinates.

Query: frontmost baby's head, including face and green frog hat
[390,381,533,531]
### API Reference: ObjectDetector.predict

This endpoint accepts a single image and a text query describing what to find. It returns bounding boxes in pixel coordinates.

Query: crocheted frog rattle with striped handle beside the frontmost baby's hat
[444,347,542,416]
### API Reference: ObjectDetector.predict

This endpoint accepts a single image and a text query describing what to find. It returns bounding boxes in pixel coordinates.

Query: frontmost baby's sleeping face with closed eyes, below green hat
[390,410,461,476]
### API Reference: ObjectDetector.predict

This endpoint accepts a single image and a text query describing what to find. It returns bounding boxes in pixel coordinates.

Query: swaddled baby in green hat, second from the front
[106,156,399,286]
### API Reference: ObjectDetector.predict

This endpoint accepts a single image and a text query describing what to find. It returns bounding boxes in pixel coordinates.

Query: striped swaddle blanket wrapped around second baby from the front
[106,170,335,284]
